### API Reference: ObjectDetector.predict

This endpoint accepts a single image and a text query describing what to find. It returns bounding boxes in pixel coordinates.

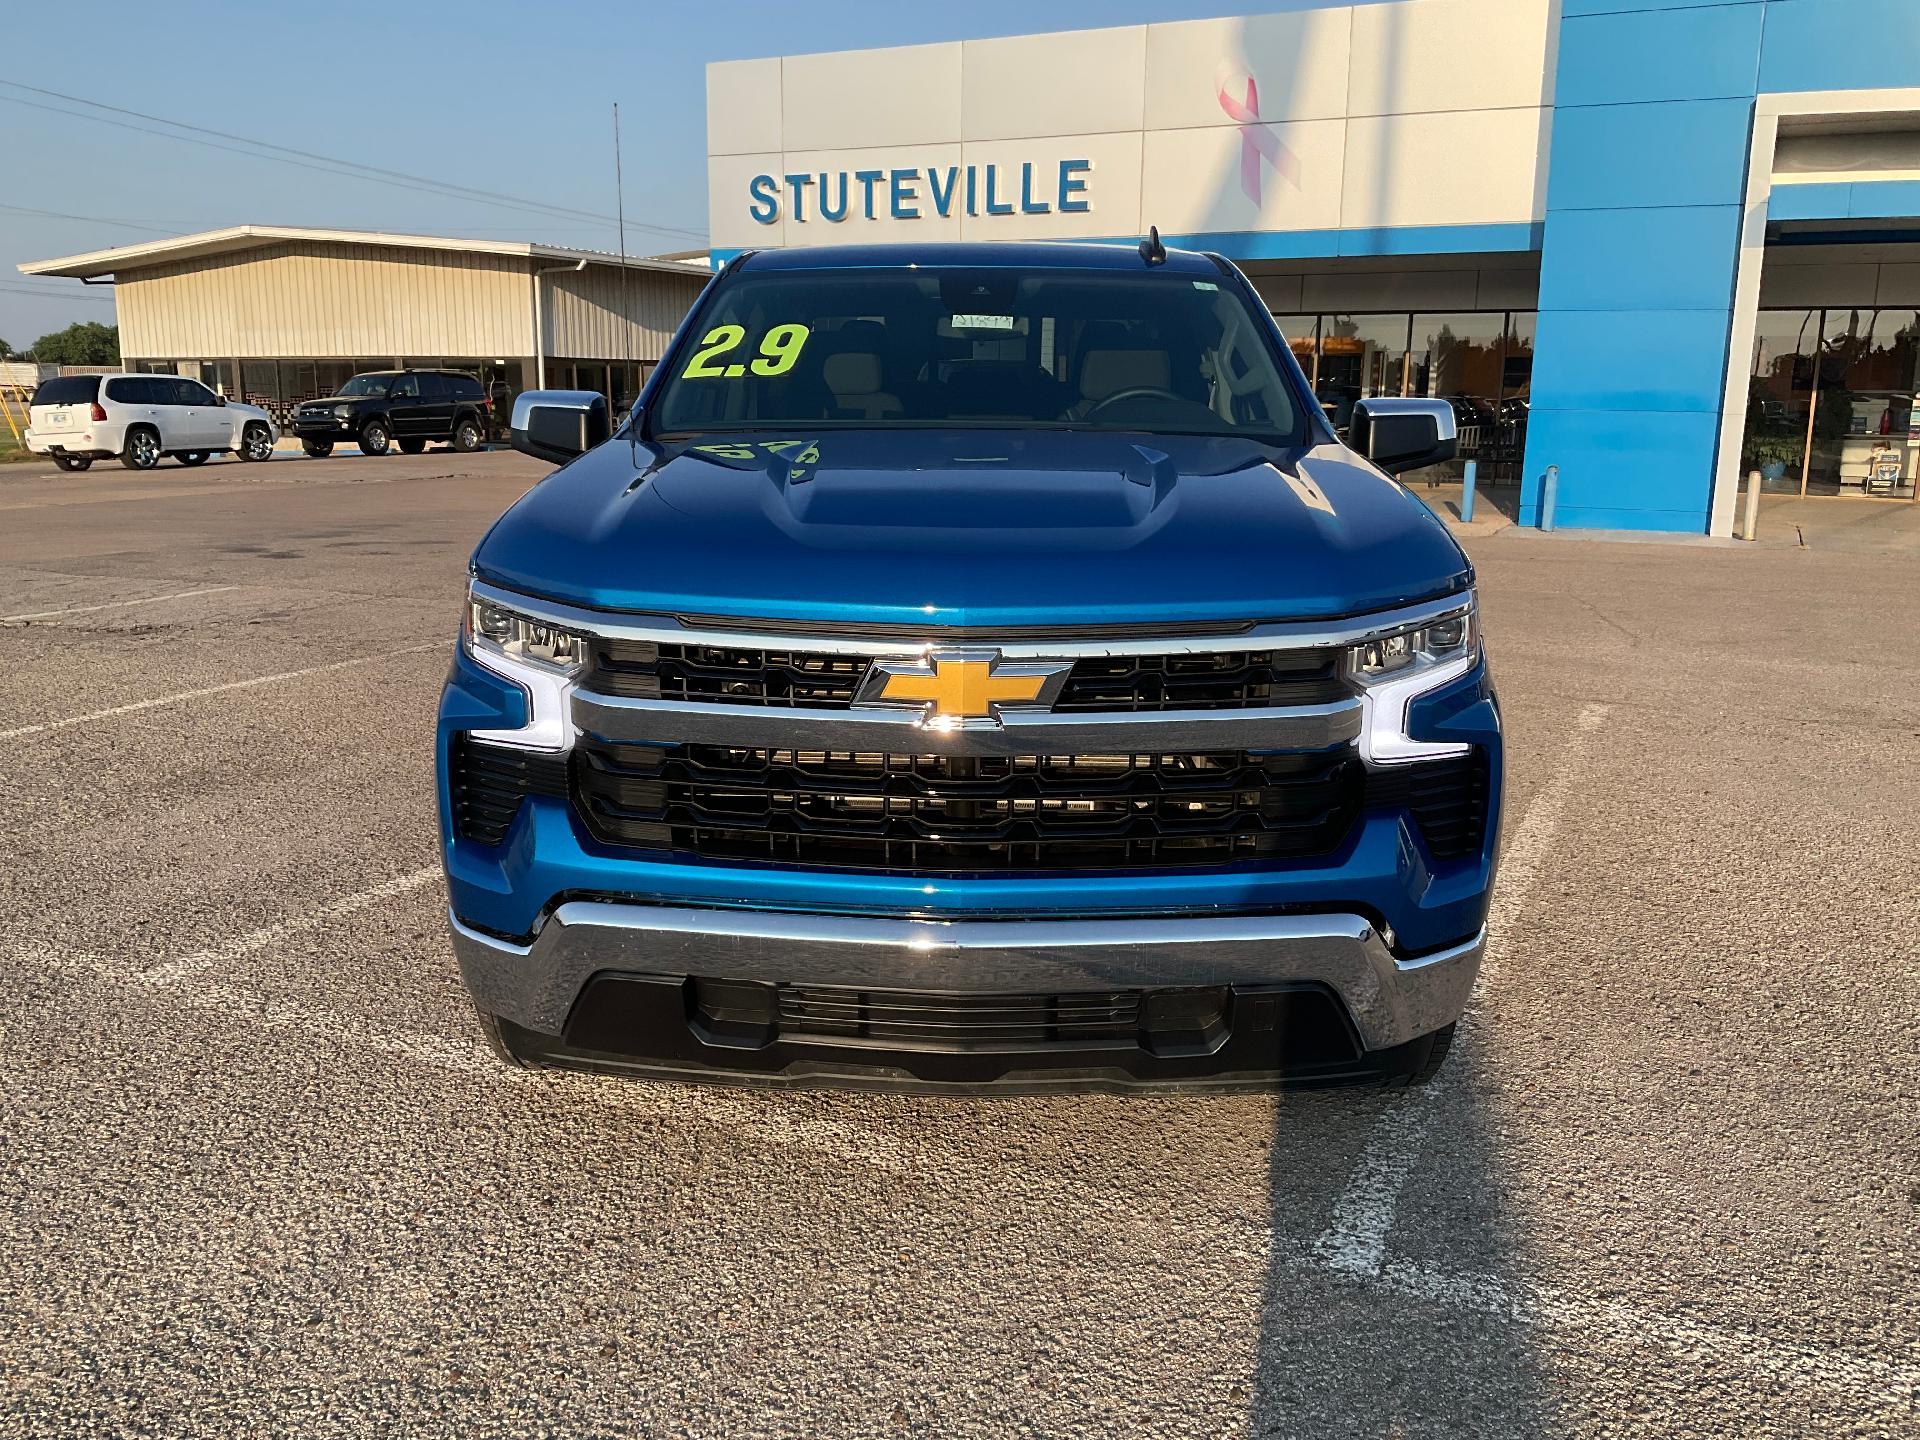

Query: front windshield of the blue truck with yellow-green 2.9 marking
[649,269,1304,444]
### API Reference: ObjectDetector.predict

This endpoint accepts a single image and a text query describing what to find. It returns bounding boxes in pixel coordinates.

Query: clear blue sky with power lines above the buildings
[0,0,1382,348]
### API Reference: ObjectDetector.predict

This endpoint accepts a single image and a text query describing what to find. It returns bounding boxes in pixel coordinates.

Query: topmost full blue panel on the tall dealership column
[1553,6,1764,108]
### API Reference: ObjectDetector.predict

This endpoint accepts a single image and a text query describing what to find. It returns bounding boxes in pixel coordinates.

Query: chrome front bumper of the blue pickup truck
[449,900,1486,1050]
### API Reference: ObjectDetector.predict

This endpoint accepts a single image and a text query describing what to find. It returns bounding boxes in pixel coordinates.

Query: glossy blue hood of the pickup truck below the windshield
[474,430,1473,626]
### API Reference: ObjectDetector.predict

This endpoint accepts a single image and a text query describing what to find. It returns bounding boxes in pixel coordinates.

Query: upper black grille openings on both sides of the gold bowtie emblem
[586,639,1348,710]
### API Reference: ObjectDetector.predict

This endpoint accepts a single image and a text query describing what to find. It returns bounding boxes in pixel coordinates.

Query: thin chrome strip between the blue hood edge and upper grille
[460,578,1473,664]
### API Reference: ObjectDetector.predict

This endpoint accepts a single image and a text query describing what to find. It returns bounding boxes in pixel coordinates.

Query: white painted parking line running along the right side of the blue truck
[1313,705,1609,1275]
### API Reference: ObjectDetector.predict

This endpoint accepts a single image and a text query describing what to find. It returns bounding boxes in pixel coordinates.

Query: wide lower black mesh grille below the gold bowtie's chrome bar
[574,739,1363,874]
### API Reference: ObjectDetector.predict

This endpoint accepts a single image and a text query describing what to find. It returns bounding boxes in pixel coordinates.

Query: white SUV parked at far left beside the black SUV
[27,374,280,470]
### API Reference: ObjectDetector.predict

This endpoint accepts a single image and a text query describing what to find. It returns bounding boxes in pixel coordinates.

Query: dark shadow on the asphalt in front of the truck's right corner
[1246,1044,1559,1440]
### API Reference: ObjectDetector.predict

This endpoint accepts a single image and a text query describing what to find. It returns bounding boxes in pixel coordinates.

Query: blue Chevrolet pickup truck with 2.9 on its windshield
[438,236,1501,1091]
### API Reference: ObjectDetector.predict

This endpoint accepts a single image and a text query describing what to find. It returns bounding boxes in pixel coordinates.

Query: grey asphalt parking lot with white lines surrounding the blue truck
[0,451,1920,1436]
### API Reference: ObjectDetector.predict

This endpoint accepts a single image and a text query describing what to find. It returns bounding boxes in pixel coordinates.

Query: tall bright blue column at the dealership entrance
[1521,0,1764,534]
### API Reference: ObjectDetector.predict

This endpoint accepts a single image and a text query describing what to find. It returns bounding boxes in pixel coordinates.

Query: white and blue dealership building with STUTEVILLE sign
[707,0,1920,536]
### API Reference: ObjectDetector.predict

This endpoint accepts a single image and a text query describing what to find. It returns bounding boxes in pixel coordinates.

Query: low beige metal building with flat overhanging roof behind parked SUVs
[19,225,708,420]
